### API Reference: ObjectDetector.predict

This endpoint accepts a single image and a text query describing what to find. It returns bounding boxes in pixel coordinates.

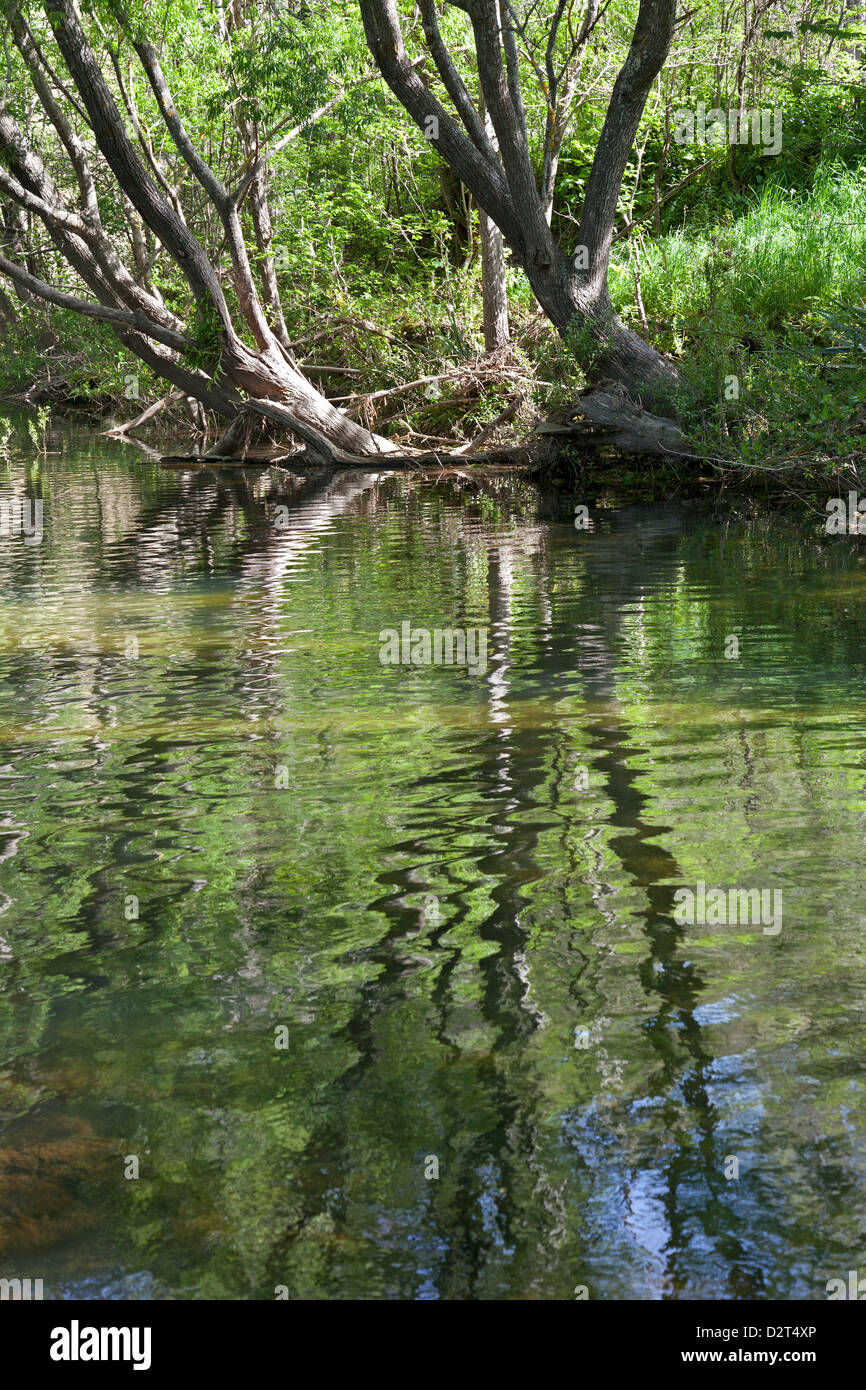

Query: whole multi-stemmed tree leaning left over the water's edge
[0,0,395,457]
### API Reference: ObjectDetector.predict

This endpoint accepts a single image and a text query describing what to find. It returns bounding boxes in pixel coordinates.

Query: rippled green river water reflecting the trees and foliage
[0,434,866,1300]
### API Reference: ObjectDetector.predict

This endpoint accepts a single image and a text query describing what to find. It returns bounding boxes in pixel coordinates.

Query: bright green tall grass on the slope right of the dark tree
[610,164,866,461]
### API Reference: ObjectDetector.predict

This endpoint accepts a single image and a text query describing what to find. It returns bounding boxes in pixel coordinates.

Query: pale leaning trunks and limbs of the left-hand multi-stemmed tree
[0,0,396,456]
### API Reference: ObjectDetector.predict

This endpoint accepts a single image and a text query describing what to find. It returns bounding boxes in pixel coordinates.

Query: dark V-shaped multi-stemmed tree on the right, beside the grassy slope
[359,0,678,404]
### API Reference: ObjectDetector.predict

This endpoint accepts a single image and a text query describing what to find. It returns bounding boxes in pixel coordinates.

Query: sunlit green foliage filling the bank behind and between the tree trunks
[0,0,866,472]
